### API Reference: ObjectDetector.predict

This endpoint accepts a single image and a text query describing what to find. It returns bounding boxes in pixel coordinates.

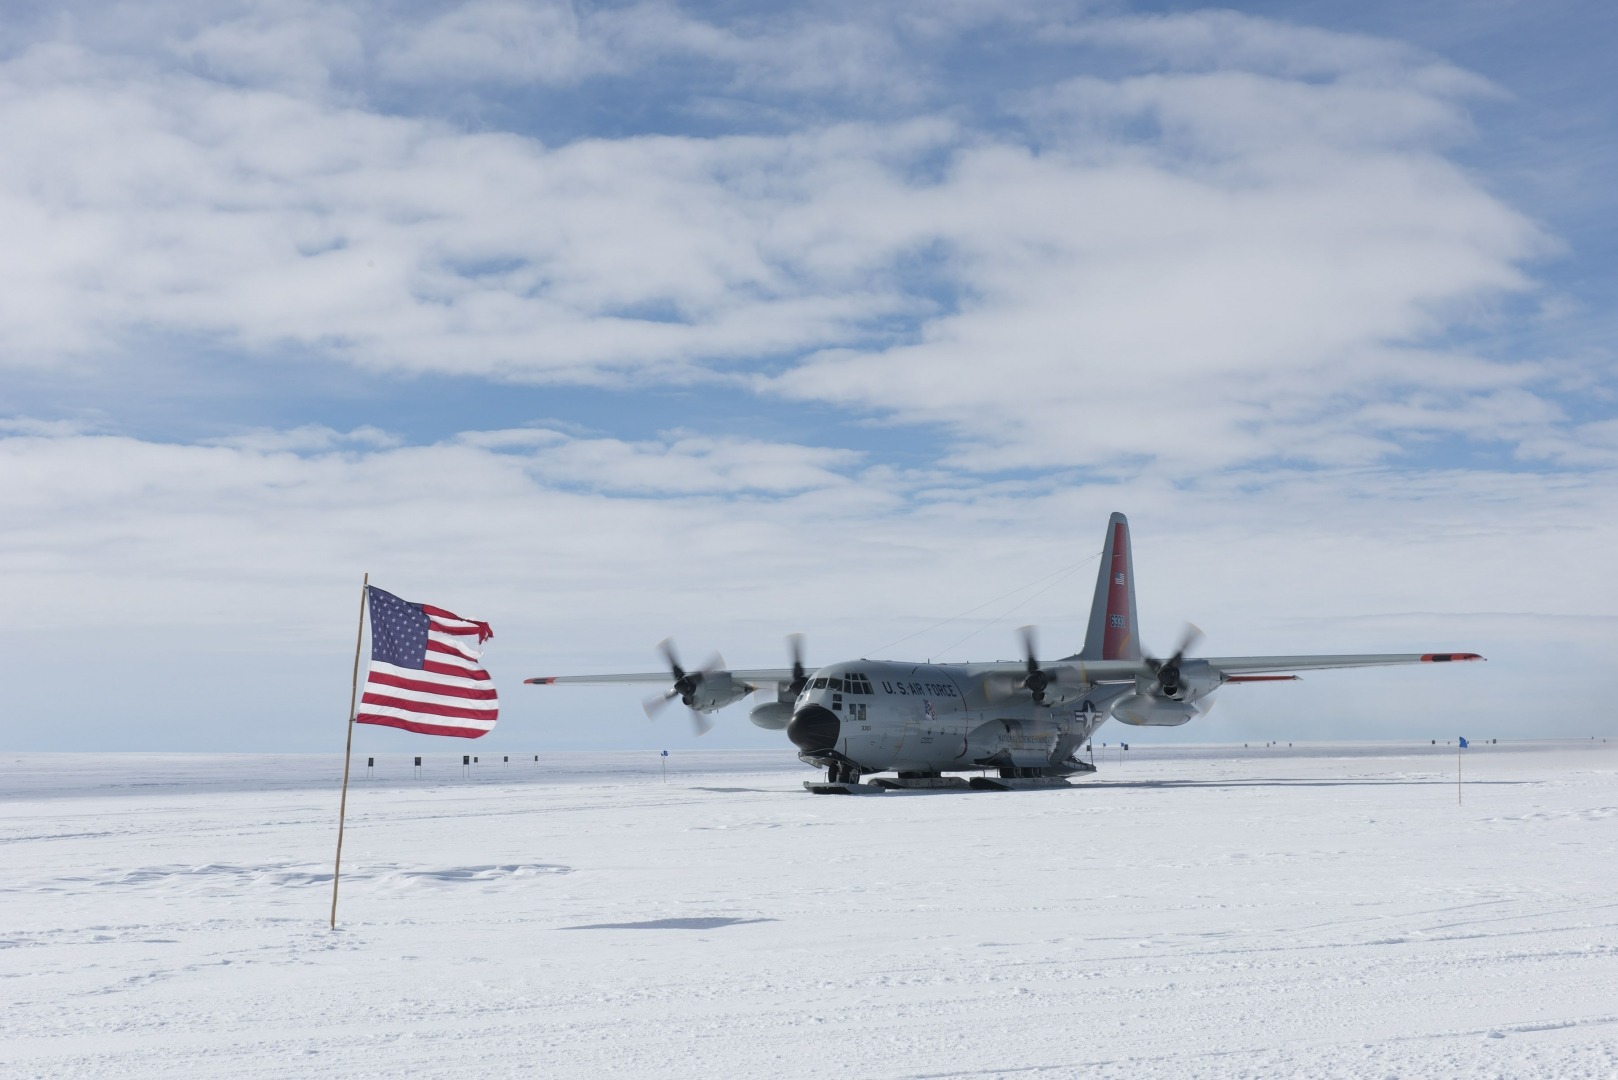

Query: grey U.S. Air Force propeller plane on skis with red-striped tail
[526,513,1484,795]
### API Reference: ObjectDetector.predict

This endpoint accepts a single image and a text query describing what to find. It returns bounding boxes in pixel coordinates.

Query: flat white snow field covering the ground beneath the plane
[0,740,1618,1077]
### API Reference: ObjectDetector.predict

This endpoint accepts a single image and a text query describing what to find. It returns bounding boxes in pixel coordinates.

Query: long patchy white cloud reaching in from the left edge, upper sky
[0,47,940,381]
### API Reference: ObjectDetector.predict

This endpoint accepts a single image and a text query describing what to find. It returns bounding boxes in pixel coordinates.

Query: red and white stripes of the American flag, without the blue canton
[354,604,500,738]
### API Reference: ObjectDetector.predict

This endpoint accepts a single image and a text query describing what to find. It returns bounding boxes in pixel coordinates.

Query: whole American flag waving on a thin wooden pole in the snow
[354,585,500,738]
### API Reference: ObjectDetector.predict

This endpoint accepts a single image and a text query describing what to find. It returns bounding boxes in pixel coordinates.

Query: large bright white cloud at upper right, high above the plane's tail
[775,61,1558,471]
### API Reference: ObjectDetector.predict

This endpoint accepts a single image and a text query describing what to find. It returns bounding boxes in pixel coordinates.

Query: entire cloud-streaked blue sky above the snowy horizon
[0,0,1618,751]
